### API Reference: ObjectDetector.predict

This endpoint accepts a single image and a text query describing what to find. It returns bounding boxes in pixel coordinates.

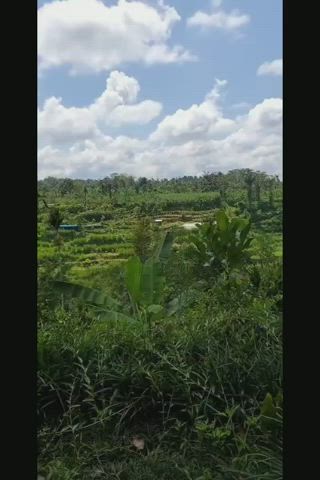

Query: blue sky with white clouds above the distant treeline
[38,0,283,179]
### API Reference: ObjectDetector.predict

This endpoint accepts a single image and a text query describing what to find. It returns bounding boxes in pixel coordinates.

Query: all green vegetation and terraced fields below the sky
[38,170,282,480]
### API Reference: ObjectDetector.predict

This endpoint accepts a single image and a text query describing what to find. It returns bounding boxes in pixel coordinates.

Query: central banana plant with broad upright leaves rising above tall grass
[52,232,174,325]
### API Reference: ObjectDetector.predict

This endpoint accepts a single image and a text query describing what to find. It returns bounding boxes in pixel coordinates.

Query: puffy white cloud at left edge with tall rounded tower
[38,71,162,145]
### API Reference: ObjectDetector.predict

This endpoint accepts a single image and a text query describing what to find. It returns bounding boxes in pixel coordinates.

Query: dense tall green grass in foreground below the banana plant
[39,282,282,480]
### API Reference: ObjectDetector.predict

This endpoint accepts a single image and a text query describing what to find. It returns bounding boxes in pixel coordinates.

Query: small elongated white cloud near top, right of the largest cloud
[187,5,250,31]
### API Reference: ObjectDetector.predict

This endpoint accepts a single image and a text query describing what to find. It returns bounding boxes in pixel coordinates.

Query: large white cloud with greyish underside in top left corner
[38,0,195,74]
